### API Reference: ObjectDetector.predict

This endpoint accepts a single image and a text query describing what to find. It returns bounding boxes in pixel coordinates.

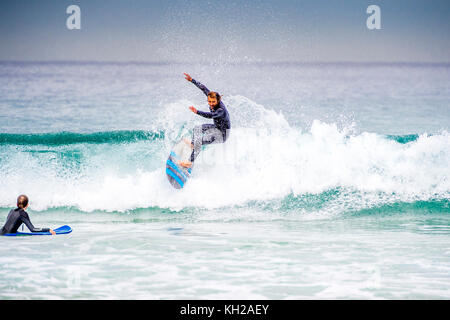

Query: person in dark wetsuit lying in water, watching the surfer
[0,194,55,235]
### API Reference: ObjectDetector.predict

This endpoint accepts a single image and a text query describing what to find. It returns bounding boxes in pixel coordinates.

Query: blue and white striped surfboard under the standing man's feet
[166,139,192,189]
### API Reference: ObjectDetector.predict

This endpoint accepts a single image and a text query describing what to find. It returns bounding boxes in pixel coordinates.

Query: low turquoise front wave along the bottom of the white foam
[0,195,450,221]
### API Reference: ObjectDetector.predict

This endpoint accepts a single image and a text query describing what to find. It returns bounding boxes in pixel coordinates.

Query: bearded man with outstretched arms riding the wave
[180,73,231,168]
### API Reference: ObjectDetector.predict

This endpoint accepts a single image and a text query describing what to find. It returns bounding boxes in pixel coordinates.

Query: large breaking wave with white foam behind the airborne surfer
[0,96,450,215]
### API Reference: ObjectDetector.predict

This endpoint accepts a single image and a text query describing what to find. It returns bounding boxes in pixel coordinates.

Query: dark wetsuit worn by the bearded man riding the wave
[191,79,231,162]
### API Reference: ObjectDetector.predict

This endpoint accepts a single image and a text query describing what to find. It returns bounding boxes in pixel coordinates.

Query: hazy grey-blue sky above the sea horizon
[0,0,450,62]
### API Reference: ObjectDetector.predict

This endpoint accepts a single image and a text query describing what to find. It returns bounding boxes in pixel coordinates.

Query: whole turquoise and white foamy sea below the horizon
[0,62,450,299]
